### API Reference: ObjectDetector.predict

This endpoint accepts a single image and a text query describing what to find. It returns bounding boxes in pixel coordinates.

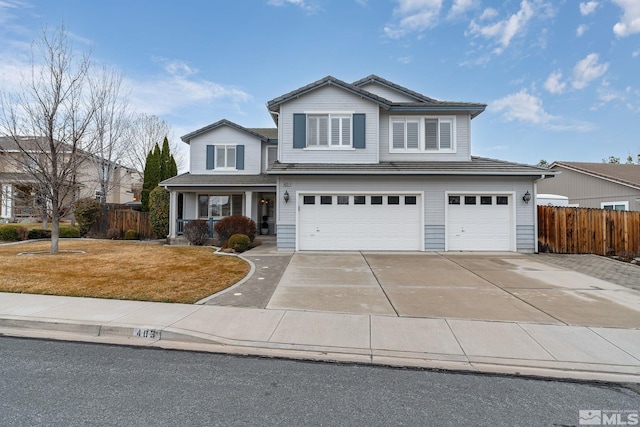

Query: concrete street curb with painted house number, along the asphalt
[0,317,640,384]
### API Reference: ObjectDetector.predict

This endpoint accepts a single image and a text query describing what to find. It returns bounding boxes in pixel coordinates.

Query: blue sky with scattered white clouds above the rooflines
[0,0,640,164]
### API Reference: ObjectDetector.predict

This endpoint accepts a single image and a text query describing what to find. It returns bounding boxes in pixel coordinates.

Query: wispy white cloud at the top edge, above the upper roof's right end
[466,0,552,54]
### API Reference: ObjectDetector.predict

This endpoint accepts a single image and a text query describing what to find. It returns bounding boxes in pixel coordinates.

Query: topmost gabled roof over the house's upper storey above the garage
[267,74,487,122]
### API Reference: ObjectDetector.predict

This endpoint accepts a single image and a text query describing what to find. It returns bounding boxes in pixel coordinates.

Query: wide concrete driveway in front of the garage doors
[267,252,640,328]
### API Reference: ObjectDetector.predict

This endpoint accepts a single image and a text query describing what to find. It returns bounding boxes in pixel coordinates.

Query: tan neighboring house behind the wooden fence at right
[538,162,640,211]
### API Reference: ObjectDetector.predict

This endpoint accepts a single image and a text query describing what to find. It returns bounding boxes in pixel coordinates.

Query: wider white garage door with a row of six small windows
[298,194,423,250]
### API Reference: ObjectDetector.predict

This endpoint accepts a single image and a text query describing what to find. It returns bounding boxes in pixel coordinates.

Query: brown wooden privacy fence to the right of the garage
[538,206,640,256]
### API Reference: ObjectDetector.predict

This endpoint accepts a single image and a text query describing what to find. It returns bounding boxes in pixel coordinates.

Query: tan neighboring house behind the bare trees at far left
[0,137,142,221]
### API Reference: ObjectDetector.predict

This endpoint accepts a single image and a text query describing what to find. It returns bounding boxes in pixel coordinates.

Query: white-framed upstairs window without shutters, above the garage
[389,116,456,153]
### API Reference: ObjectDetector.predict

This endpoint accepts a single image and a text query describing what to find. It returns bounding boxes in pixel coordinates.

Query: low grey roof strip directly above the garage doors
[267,156,556,178]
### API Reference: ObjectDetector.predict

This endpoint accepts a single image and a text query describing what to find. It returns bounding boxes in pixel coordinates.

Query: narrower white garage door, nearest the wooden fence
[447,194,515,251]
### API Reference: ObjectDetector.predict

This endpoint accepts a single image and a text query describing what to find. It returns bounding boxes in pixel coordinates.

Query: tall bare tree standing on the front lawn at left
[0,26,96,253]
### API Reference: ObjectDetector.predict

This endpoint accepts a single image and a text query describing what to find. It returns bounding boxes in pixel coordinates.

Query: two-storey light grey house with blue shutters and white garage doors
[161,75,554,252]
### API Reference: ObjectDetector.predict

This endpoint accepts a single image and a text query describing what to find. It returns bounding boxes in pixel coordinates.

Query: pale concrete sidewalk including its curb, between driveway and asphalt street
[0,293,640,383]
